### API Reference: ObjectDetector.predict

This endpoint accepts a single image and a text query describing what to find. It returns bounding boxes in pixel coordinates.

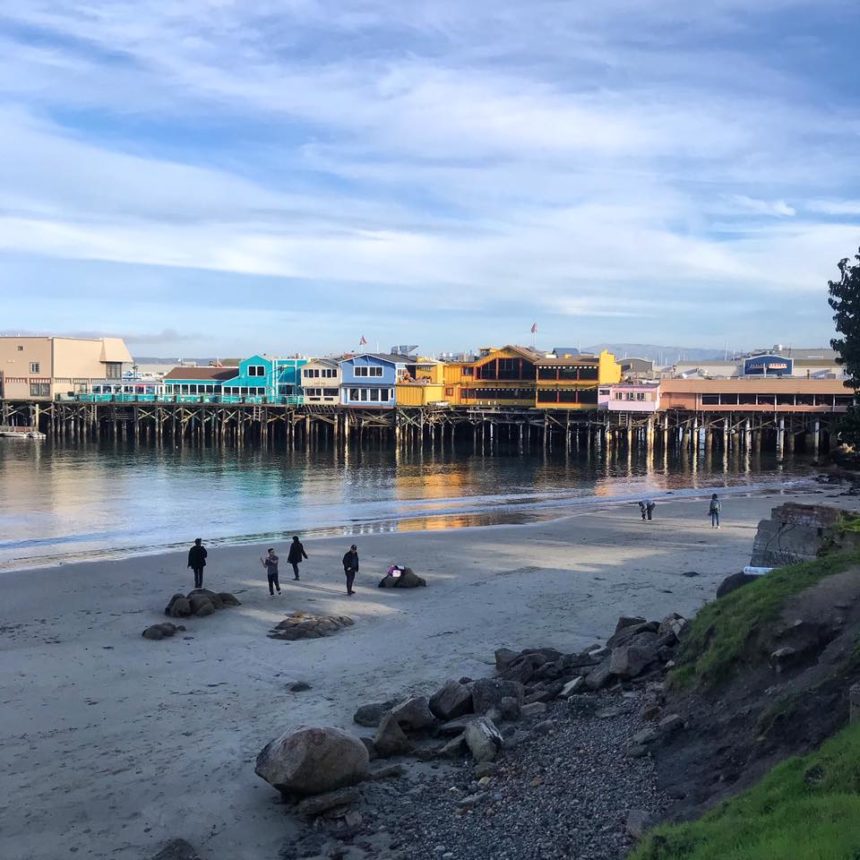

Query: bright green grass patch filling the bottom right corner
[630,723,860,860]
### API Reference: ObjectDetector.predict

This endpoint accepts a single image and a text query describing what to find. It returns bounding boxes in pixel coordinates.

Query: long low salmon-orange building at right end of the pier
[660,376,854,413]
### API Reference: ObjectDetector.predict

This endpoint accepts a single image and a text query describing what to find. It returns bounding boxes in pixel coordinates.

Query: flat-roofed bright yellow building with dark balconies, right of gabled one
[535,350,621,409]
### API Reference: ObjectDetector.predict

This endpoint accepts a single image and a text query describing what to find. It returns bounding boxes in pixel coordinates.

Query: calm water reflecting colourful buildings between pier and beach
[0,439,809,570]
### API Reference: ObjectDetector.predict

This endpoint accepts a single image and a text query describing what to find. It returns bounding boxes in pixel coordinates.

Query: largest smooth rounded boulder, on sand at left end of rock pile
[255,727,370,795]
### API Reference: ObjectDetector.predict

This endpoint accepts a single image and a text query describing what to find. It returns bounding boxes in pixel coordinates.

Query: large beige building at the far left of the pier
[0,337,133,400]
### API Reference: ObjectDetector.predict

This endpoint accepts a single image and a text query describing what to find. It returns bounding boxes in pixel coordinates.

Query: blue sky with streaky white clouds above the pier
[0,0,860,357]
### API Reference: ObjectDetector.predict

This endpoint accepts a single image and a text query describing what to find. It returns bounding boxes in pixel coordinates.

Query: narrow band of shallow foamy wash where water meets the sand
[0,476,819,582]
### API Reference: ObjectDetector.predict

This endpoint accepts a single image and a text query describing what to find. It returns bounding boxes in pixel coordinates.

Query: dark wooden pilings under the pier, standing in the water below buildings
[0,400,841,456]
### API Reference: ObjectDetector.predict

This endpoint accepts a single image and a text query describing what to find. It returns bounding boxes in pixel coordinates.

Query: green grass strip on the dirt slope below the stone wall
[670,552,860,692]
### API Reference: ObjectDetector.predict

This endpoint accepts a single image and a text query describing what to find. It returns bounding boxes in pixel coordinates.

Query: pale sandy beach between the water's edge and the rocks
[0,490,856,860]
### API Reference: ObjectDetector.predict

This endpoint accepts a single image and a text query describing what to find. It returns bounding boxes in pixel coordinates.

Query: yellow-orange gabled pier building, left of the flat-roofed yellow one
[444,346,543,408]
